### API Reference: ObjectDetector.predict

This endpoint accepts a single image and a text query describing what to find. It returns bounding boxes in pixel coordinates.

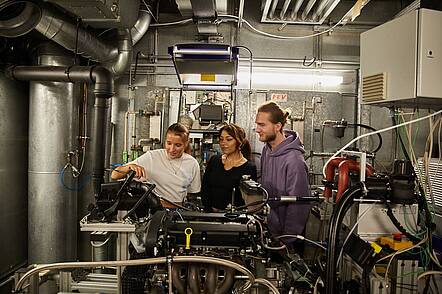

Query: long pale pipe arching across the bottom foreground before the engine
[15,256,255,293]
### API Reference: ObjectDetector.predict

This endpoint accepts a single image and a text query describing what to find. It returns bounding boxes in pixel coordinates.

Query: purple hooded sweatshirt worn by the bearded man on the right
[261,130,311,241]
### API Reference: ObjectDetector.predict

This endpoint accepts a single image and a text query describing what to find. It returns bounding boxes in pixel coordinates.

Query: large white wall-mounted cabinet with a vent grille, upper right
[360,9,442,108]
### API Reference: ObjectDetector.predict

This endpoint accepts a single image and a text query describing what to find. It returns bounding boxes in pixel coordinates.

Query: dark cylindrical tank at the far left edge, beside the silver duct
[0,73,28,278]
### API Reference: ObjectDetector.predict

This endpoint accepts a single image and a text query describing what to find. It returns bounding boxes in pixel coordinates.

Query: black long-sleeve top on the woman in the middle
[201,155,257,211]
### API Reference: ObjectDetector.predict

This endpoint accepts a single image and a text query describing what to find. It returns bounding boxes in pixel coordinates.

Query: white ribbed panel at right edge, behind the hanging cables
[416,158,442,212]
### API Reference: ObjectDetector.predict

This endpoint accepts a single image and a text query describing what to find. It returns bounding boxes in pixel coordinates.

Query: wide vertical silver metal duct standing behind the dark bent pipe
[24,43,78,263]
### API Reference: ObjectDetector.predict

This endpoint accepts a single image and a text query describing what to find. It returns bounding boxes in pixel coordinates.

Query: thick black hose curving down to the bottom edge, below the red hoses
[325,183,363,294]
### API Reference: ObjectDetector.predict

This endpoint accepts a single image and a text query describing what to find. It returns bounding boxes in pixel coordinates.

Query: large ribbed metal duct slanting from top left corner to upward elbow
[0,1,152,75]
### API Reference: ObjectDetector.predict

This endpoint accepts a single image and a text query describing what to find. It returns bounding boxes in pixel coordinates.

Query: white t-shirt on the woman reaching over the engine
[128,149,201,202]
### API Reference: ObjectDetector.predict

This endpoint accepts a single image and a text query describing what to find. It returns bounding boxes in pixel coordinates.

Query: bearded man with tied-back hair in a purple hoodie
[255,102,311,248]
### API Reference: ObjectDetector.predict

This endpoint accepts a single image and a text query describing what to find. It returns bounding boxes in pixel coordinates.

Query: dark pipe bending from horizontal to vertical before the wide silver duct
[7,66,114,197]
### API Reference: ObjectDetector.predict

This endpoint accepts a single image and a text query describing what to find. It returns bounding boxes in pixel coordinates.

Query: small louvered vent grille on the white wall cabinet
[362,72,387,102]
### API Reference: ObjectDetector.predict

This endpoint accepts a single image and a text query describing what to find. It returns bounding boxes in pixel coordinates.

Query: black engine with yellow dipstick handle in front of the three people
[83,171,317,294]
